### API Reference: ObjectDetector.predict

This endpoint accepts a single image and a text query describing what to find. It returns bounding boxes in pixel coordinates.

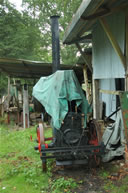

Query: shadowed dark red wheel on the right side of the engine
[89,120,102,167]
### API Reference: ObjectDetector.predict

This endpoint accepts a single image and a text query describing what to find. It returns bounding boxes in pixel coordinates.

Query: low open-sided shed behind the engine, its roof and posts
[0,58,83,128]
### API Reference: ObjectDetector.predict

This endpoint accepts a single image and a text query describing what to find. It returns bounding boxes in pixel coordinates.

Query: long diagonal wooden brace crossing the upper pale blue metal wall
[99,18,126,68]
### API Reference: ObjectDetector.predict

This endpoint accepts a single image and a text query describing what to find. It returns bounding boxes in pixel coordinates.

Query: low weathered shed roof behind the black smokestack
[0,58,82,78]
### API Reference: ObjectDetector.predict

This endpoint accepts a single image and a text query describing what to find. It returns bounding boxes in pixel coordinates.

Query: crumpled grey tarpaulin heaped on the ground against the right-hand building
[102,110,125,162]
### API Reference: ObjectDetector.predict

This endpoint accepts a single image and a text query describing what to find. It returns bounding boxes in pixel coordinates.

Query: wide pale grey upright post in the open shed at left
[23,84,29,129]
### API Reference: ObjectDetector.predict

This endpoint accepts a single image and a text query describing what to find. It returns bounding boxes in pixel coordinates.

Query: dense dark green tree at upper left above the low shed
[0,0,44,60]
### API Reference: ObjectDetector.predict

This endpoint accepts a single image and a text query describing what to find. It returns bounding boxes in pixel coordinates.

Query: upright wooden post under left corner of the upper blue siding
[93,79,100,120]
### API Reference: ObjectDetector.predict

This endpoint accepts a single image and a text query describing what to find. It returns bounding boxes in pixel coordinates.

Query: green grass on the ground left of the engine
[0,125,77,193]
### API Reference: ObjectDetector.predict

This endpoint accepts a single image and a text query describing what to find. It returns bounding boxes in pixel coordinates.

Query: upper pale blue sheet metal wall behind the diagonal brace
[92,13,125,79]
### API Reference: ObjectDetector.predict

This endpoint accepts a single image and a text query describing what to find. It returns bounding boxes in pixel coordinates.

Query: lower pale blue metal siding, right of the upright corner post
[99,79,116,119]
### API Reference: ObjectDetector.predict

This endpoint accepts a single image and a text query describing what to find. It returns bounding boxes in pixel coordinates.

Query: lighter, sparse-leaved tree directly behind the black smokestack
[23,0,82,64]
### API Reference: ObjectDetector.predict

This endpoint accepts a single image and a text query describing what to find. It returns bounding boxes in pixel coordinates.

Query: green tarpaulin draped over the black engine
[33,70,90,129]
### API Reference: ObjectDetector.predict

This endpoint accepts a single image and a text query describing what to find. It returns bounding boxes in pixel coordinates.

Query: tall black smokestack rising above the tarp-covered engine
[51,15,60,73]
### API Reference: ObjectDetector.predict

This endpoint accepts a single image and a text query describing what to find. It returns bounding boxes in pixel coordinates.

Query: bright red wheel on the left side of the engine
[37,123,47,172]
